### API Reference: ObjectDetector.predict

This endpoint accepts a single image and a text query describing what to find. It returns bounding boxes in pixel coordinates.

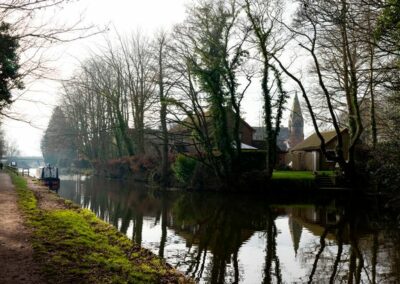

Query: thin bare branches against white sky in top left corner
[0,0,97,81]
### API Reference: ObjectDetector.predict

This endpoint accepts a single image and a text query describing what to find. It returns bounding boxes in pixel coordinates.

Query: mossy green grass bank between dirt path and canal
[10,174,186,283]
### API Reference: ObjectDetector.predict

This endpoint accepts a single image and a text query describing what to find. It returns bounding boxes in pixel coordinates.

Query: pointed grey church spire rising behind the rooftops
[289,93,304,148]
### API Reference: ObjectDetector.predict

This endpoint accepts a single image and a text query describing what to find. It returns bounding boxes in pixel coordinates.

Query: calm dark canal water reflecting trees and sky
[58,176,400,284]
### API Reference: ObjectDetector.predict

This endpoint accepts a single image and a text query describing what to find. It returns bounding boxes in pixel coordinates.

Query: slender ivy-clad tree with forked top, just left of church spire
[245,0,287,178]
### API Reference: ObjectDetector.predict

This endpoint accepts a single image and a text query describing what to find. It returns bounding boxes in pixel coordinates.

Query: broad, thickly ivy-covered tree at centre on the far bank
[178,0,248,180]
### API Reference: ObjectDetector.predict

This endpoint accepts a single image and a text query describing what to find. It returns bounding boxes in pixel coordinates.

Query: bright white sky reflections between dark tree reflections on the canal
[60,177,400,284]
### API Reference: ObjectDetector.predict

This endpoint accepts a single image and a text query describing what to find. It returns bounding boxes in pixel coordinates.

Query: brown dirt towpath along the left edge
[0,172,44,284]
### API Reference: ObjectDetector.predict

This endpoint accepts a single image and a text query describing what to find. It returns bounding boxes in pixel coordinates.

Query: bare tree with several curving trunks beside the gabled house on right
[273,0,386,178]
